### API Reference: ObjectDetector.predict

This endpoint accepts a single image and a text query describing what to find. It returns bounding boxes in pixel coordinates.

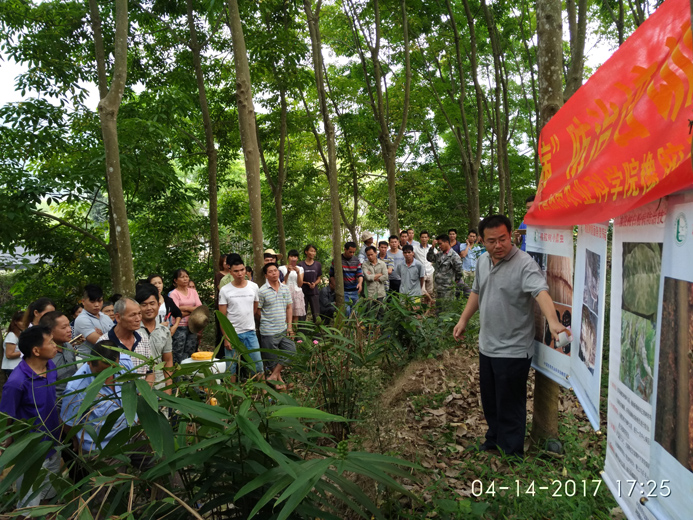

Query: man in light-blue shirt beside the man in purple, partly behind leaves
[60,340,133,453]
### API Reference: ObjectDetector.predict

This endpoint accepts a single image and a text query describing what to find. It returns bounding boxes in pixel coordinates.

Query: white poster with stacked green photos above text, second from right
[603,199,667,519]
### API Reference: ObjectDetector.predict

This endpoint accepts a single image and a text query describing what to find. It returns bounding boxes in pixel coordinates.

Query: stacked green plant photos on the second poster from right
[619,242,662,402]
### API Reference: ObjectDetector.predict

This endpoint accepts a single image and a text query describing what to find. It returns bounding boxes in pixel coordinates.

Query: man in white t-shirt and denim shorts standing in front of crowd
[219,257,264,380]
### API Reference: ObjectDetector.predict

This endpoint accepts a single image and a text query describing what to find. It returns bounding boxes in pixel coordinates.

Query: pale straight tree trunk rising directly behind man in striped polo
[228,0,265,285]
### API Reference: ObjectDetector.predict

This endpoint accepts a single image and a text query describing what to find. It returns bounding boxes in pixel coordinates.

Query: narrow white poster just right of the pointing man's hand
[570,224,609,430]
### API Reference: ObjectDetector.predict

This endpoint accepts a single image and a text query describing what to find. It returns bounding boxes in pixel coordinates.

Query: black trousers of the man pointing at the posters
[479,353,532,456]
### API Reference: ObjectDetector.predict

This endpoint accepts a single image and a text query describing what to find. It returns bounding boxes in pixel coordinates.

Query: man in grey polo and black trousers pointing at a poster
[453,215,566,457]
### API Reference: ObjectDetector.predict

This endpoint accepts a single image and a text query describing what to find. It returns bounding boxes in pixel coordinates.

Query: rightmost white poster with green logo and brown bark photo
[644,192,693,518]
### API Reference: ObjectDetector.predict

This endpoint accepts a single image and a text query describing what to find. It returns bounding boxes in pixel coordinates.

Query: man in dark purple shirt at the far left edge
[0,325,60,508]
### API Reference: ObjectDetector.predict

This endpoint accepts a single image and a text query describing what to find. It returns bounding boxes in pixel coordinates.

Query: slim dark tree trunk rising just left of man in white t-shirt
[186,0,221,270]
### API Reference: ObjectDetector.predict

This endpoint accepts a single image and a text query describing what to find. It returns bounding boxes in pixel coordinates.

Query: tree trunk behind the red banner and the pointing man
[530,0,563,444]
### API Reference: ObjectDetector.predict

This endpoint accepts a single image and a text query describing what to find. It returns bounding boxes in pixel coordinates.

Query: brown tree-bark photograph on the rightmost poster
[655,277,693,471]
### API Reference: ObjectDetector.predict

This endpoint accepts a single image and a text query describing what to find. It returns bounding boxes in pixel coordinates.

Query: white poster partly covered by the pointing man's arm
[526,226,573,387]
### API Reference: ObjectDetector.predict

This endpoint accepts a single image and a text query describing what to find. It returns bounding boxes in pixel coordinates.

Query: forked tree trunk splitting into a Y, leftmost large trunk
[89,0,135,296]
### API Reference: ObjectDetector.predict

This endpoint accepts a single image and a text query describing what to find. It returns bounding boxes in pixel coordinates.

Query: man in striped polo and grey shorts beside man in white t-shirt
[257,263,296,390]
